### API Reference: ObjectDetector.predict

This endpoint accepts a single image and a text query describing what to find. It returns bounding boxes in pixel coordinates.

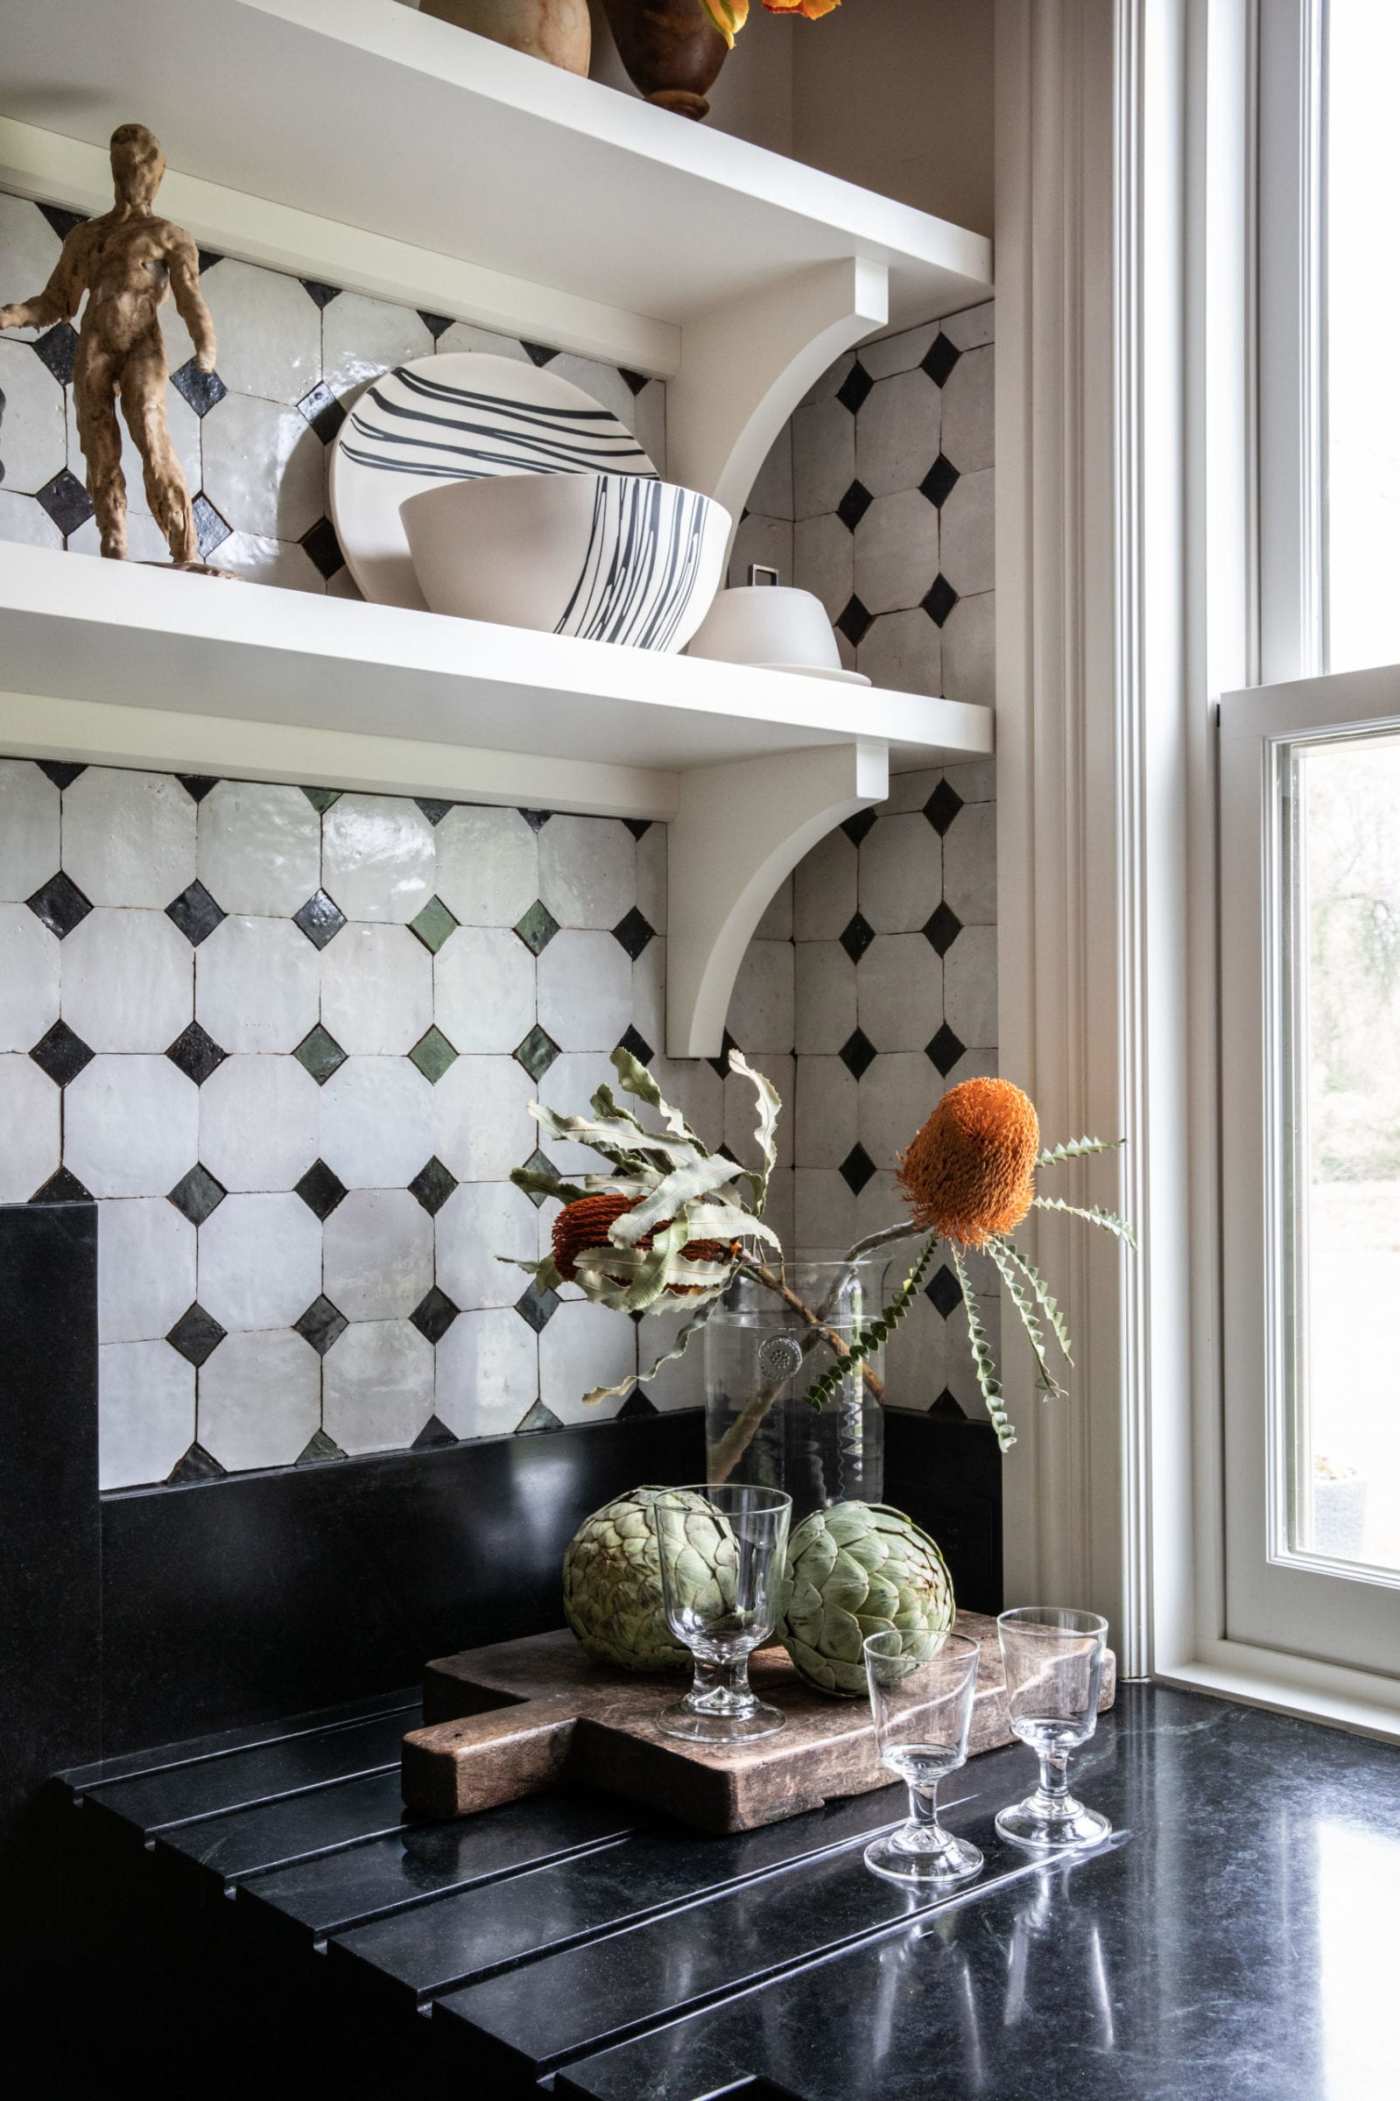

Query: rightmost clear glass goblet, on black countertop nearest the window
[996,1605,1112,1853]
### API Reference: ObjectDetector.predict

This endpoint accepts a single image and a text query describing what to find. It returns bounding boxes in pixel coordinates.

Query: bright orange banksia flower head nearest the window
[900,1080,1041,1248]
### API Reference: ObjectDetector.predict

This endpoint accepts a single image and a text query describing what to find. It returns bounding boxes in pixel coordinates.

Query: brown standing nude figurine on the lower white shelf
[0,124,214,565]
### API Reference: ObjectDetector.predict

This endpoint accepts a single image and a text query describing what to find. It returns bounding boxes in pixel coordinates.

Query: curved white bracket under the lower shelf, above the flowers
[666,740,889,1057]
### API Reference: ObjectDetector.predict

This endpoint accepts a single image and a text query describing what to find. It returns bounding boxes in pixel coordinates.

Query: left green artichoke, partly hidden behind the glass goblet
[563,1488,734,1670]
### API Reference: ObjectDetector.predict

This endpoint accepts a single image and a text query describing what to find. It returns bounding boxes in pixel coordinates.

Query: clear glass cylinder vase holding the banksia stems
[704,1254,885,1523]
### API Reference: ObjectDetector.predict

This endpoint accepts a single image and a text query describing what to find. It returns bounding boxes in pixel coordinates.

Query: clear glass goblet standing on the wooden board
[652,1481,792,1744]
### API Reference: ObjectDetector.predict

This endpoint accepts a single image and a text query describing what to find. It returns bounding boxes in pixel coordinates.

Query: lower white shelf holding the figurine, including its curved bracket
[0,546,992,1055]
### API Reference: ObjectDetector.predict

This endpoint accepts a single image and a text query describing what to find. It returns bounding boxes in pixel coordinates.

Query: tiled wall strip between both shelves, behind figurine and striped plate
[0,191,666,599]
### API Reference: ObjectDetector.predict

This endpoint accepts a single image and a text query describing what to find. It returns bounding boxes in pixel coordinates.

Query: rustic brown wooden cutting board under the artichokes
[404,1611,1116,1832]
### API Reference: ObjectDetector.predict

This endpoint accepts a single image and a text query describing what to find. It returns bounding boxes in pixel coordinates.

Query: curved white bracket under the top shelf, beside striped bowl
[666,256,889,558]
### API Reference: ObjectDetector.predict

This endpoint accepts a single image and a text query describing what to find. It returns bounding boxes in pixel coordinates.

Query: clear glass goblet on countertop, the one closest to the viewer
[864,1628,982,1889]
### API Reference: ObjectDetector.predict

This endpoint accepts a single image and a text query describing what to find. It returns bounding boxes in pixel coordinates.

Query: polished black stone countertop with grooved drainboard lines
[67,1685,1400,2101]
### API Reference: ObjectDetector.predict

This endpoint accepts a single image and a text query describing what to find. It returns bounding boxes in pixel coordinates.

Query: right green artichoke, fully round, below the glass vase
[778,1502,954,1696]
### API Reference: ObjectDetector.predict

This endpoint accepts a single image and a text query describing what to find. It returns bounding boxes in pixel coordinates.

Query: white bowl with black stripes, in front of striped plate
[399,475,729,649]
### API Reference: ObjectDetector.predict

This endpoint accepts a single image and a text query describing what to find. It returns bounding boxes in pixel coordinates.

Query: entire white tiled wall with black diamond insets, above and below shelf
[0,195,996,1488]
